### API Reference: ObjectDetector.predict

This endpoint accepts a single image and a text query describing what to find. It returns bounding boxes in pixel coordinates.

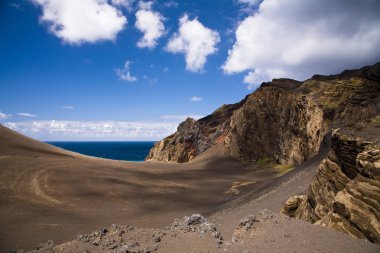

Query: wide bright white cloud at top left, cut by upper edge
[32,0,127,44]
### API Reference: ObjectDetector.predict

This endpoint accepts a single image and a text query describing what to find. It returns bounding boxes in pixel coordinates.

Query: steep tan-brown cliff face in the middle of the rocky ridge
[225,80,328,164]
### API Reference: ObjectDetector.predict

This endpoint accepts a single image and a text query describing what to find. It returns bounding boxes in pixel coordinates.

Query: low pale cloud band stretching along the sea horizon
[4,120,179,141]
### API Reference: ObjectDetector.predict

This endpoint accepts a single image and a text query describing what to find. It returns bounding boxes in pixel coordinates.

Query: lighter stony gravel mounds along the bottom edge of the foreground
[14,209,380,253]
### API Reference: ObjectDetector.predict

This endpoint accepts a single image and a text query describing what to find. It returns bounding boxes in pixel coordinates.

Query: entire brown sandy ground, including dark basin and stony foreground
[0,126,380,252]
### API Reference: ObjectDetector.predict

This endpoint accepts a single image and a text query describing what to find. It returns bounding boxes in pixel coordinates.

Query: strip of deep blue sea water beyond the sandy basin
[47,141,155,162]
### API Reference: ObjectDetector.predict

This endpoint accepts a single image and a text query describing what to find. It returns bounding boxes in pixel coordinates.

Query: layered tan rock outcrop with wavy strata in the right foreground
[282,129,380,243]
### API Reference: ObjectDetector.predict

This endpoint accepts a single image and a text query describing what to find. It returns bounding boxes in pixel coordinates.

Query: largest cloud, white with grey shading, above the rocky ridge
[223,0,380,87]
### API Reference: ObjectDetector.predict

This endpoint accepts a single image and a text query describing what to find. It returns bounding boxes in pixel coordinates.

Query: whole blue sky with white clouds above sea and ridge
[0,0,380,141]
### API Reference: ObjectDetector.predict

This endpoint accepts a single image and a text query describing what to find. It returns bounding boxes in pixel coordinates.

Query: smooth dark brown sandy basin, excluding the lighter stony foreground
[0,126,278,250]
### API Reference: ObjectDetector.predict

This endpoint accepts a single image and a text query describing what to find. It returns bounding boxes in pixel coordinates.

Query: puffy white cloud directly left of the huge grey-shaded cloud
[166,15,220,72]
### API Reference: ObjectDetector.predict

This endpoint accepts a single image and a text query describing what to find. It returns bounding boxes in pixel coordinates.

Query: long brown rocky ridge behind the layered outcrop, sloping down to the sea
[147,63,380,165]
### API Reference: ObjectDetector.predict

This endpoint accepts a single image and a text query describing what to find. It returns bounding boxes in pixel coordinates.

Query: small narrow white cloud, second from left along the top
[135,2,165,48]
